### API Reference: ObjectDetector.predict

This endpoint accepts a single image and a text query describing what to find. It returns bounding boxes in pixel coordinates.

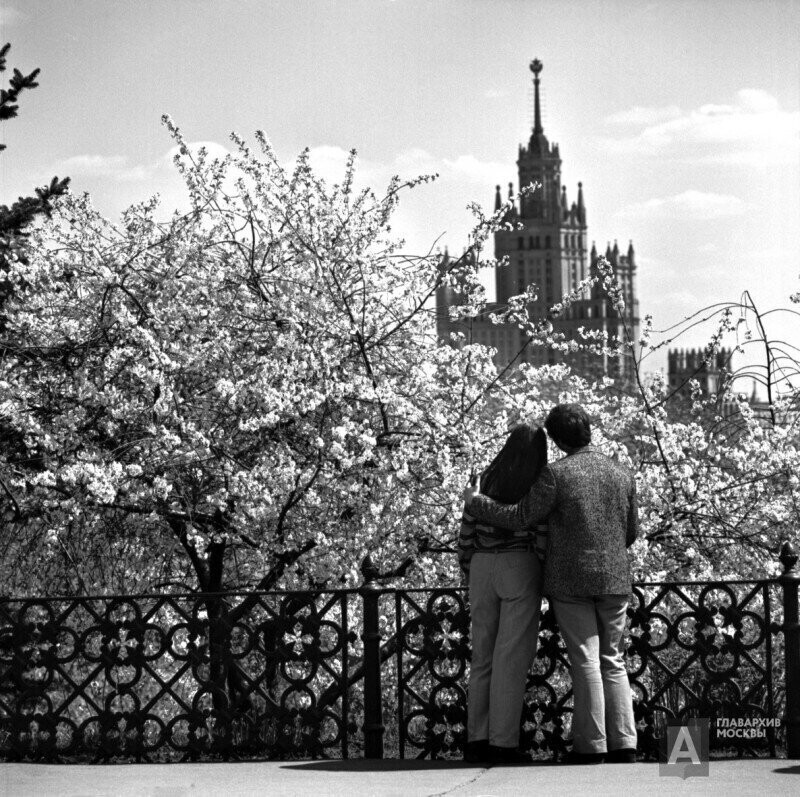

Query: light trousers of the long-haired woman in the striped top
[467,551,542,748]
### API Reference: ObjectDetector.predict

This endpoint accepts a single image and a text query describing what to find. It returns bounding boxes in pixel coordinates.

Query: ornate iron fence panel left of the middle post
[0,592,357,761]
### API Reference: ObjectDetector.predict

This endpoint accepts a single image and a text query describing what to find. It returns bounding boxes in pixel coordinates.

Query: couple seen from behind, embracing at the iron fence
[459,404,638,763]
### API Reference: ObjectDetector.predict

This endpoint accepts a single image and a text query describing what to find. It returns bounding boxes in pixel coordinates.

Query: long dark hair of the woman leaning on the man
[481,423,547,504]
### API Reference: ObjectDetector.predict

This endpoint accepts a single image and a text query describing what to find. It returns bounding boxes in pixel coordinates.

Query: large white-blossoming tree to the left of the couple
[2,119,552,591]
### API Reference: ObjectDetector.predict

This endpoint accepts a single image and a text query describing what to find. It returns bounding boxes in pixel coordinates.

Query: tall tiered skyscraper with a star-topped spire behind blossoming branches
[437,59,639,381]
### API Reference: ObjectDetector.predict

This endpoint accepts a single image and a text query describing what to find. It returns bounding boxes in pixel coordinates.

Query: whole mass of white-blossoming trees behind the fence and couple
[0,115,800,592]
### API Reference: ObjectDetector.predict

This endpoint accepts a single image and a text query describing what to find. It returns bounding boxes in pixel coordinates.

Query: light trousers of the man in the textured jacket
[552,595,636,753]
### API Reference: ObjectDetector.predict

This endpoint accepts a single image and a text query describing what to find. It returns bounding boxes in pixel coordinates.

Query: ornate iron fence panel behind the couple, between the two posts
[393,581,776,758]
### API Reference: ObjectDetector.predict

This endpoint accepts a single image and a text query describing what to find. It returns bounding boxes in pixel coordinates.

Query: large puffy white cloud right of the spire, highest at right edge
[602,89,800,165]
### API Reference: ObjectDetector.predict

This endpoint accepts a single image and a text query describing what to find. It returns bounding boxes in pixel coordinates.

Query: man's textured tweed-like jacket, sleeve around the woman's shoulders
[469,446,639,596]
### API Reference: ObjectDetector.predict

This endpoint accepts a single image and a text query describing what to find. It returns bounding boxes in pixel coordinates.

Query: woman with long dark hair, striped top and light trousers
[459,424,547,763]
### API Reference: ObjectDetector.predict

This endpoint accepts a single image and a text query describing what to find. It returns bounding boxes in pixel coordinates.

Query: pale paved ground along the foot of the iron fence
[0,759,800,797]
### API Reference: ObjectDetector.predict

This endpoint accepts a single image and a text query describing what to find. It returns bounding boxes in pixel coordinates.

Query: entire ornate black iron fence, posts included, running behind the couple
[0,546,800,761]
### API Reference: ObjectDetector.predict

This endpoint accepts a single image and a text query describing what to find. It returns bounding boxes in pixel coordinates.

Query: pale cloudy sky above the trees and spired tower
[0,0,800,382]
